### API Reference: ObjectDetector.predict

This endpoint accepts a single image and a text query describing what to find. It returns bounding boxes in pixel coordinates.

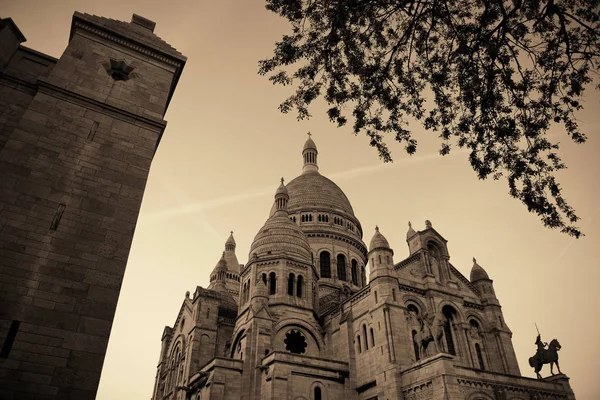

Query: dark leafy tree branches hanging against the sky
[259,0,600,237]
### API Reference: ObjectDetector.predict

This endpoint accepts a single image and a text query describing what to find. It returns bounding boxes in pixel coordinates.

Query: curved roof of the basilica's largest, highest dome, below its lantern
[271,171,354,217]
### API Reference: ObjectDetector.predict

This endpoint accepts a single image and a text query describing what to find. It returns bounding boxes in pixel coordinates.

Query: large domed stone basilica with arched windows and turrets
[152,138,575,400]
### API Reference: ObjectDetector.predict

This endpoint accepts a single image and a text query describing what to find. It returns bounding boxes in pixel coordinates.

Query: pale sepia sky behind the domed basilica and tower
[0,0,600,400]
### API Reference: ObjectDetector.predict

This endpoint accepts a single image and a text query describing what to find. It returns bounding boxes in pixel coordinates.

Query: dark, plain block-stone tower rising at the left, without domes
[0,12,186,399]
